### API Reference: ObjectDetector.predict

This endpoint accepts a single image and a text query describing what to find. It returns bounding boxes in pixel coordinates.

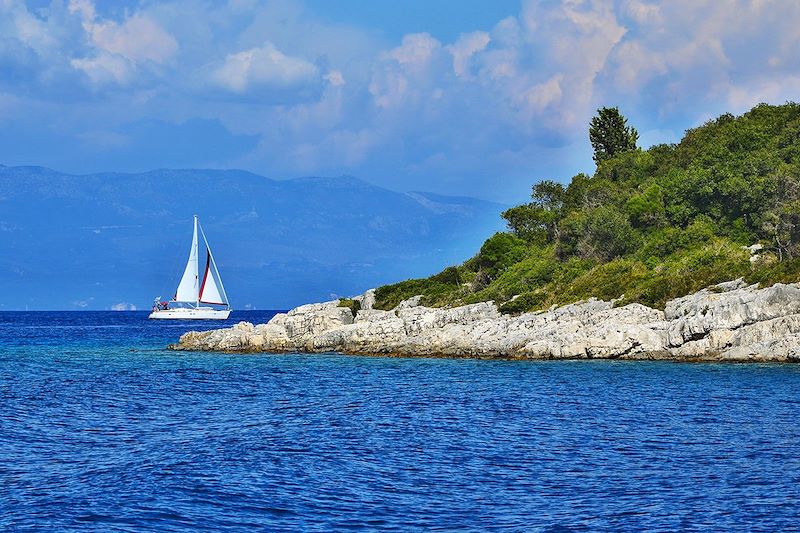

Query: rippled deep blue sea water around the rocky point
[0,312,800,533]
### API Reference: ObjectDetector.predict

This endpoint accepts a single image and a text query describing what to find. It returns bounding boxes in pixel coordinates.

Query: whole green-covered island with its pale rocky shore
[171,103,800,362]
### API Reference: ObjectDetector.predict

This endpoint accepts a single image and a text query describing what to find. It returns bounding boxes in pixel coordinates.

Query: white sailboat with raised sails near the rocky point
[148,215,231,320]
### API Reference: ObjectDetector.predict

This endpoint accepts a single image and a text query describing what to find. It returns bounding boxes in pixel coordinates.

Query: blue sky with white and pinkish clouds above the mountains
[0,0,800,203]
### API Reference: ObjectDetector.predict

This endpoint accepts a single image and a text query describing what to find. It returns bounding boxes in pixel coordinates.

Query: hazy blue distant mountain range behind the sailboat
[0,165,504,310]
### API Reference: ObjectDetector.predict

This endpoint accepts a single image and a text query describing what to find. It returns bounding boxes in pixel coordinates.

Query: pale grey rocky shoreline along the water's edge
[169,280,800,362]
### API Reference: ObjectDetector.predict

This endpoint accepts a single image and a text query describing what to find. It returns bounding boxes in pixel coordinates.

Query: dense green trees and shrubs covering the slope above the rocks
[376,103,800,313]
